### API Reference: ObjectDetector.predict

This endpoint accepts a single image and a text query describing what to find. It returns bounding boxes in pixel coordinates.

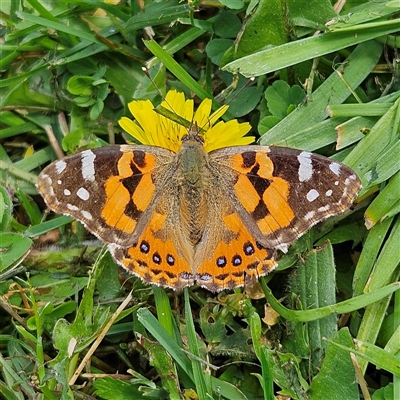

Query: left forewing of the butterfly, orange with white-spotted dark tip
[37,146,175,246]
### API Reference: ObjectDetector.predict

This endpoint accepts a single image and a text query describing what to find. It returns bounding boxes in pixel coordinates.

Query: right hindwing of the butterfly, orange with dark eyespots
[194,191,277,292]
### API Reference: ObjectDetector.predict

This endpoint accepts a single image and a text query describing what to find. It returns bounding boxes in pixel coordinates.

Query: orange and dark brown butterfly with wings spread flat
[37,125,361,292]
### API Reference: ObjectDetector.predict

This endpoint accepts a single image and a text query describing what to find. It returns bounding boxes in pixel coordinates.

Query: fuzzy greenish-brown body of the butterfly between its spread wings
[177,130,209,246]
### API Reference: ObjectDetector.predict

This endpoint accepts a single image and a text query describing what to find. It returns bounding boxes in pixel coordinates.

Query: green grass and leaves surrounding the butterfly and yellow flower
[0,0,400,400]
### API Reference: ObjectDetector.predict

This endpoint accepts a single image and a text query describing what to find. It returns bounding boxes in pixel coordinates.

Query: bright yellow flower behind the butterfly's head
[118,90,254,152]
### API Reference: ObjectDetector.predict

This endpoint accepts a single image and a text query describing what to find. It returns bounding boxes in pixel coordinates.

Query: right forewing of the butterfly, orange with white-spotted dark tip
[210,146,361,251]
